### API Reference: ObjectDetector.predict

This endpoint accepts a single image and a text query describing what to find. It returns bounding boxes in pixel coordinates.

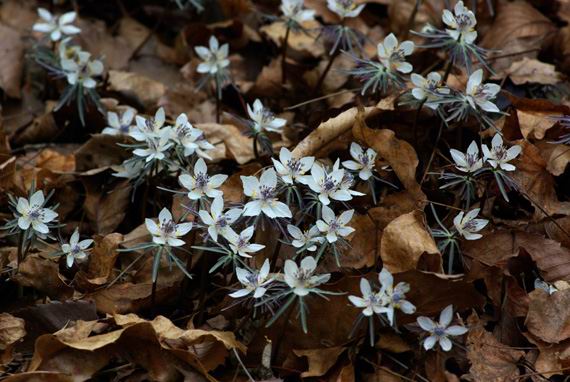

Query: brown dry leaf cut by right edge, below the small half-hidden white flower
[525,289,570,344]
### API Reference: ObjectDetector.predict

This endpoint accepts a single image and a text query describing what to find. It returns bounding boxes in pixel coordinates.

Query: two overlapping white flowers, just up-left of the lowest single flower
[348,268,416,325]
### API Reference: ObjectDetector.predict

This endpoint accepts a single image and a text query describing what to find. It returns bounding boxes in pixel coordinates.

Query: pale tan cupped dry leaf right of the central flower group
[380,211,442,273]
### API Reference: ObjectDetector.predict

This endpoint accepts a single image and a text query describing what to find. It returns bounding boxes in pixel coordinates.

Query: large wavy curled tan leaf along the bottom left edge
[29,314,245,381]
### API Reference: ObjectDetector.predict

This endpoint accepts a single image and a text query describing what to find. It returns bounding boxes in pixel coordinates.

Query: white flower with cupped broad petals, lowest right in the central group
[283,256,331,297]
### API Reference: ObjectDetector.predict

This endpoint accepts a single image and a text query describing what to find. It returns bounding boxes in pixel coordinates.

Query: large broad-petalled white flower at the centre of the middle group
[241,168,293,219]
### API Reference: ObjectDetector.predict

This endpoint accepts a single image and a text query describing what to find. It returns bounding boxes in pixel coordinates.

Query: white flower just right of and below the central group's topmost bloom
[302,163,352,206]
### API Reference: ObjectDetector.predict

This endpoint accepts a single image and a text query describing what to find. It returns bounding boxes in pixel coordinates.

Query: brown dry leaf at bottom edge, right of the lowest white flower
[467,313,525,382]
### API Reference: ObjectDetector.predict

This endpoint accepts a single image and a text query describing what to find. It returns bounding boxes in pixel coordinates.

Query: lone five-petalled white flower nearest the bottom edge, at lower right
[417,305,469,351]
